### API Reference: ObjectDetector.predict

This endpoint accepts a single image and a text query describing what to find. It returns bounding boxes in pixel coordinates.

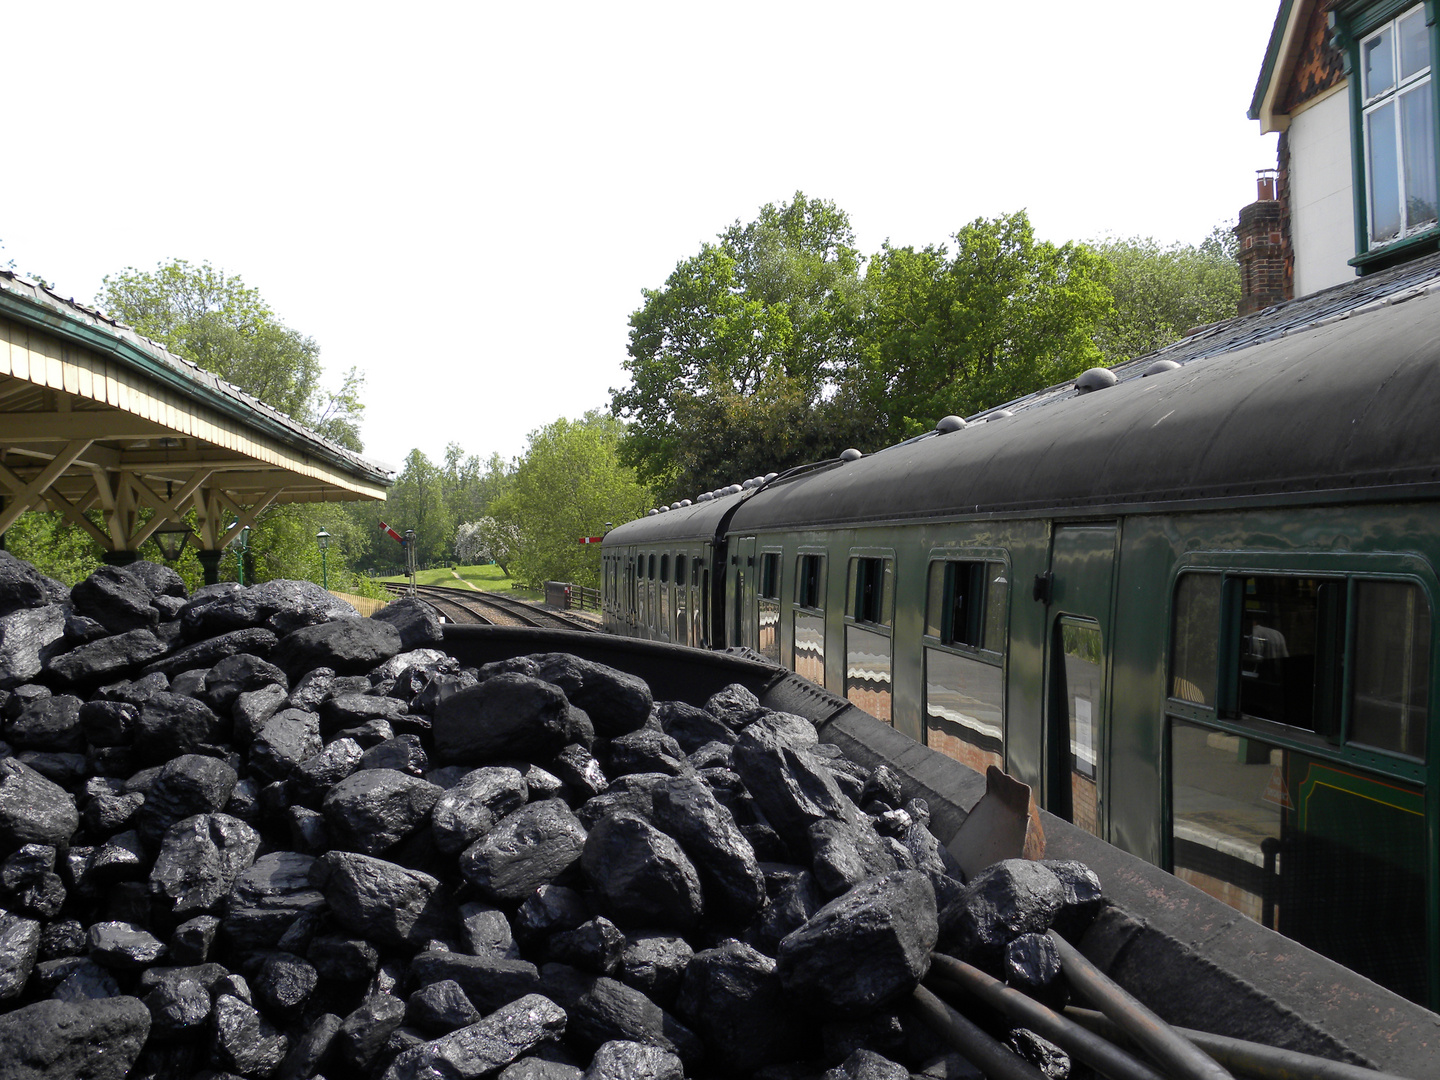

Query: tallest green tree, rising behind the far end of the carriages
[611,192,863,501]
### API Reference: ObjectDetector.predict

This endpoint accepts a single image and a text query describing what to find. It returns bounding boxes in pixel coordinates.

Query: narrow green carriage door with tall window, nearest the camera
[1035,524,1117,837]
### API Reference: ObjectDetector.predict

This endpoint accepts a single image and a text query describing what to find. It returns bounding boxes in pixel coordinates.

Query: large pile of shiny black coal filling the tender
[0,550,1099,1080]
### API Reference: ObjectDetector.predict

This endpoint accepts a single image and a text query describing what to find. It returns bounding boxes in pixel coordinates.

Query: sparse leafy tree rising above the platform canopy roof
[95,259,364,451]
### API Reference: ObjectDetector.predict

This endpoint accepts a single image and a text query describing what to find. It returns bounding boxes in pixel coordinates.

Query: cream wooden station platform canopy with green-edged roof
[0,271,395,577]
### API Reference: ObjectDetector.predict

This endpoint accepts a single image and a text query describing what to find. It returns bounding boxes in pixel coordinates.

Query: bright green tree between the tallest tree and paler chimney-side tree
[848,210,1112,439]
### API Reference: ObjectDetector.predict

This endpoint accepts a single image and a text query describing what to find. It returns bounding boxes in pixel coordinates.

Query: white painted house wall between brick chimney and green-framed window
[1290,82,1355,297]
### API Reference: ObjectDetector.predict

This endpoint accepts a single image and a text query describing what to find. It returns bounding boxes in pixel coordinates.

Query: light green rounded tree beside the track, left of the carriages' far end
[491,412,652,586]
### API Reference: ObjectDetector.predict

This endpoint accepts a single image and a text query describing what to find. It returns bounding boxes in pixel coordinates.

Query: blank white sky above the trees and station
[0,0,1277,468]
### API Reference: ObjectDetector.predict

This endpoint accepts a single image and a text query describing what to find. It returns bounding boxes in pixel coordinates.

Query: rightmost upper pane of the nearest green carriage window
[1349,580,1430,757]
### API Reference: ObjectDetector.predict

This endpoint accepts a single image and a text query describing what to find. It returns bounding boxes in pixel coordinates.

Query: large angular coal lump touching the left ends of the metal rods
[779,870,939,1017]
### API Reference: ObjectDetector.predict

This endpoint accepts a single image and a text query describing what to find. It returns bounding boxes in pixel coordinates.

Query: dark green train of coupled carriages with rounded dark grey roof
[605,264,1440,1008]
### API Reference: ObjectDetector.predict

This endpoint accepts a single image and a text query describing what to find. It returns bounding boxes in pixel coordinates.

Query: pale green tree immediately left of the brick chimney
[1096,226,1240,364]
